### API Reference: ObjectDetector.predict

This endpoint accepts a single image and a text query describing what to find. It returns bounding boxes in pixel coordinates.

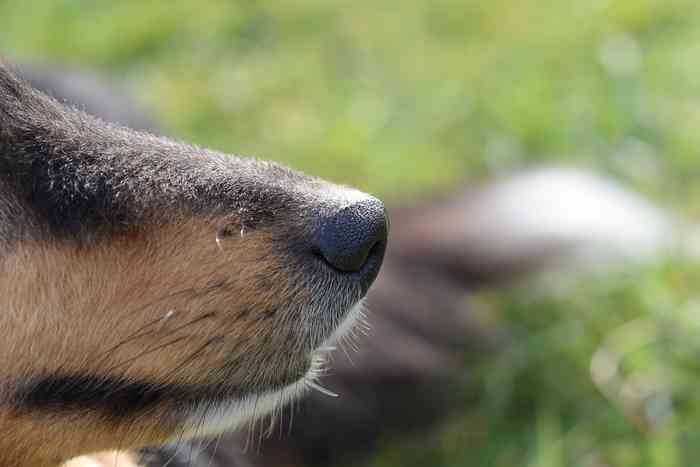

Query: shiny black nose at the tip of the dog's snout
[317,197,388,280]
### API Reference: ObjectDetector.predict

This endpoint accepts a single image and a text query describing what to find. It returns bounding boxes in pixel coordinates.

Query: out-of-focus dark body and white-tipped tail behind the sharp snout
[12,62,678,467]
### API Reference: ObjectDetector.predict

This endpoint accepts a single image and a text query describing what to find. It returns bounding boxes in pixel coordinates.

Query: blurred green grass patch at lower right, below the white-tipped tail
[371,260,700,467]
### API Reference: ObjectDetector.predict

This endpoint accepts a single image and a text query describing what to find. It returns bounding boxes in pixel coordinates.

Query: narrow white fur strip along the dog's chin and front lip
[172,300,364,442]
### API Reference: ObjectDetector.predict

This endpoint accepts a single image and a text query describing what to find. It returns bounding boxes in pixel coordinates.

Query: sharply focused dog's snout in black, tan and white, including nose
[0,64,388,467]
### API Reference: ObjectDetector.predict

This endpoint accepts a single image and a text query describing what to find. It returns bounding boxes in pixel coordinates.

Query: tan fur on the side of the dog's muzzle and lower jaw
[0,220,320,467]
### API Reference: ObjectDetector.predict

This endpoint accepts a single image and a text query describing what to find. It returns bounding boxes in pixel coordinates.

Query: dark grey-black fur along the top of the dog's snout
[0,61,332,247]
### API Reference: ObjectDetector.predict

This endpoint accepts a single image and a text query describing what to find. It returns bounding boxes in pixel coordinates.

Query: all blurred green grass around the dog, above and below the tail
[0,0,700,467]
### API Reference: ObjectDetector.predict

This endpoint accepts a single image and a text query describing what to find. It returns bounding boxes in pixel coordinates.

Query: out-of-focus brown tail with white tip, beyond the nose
[391,168,681,285]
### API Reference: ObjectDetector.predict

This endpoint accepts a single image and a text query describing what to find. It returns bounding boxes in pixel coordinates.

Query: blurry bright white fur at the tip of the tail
[464,168,678,267]
